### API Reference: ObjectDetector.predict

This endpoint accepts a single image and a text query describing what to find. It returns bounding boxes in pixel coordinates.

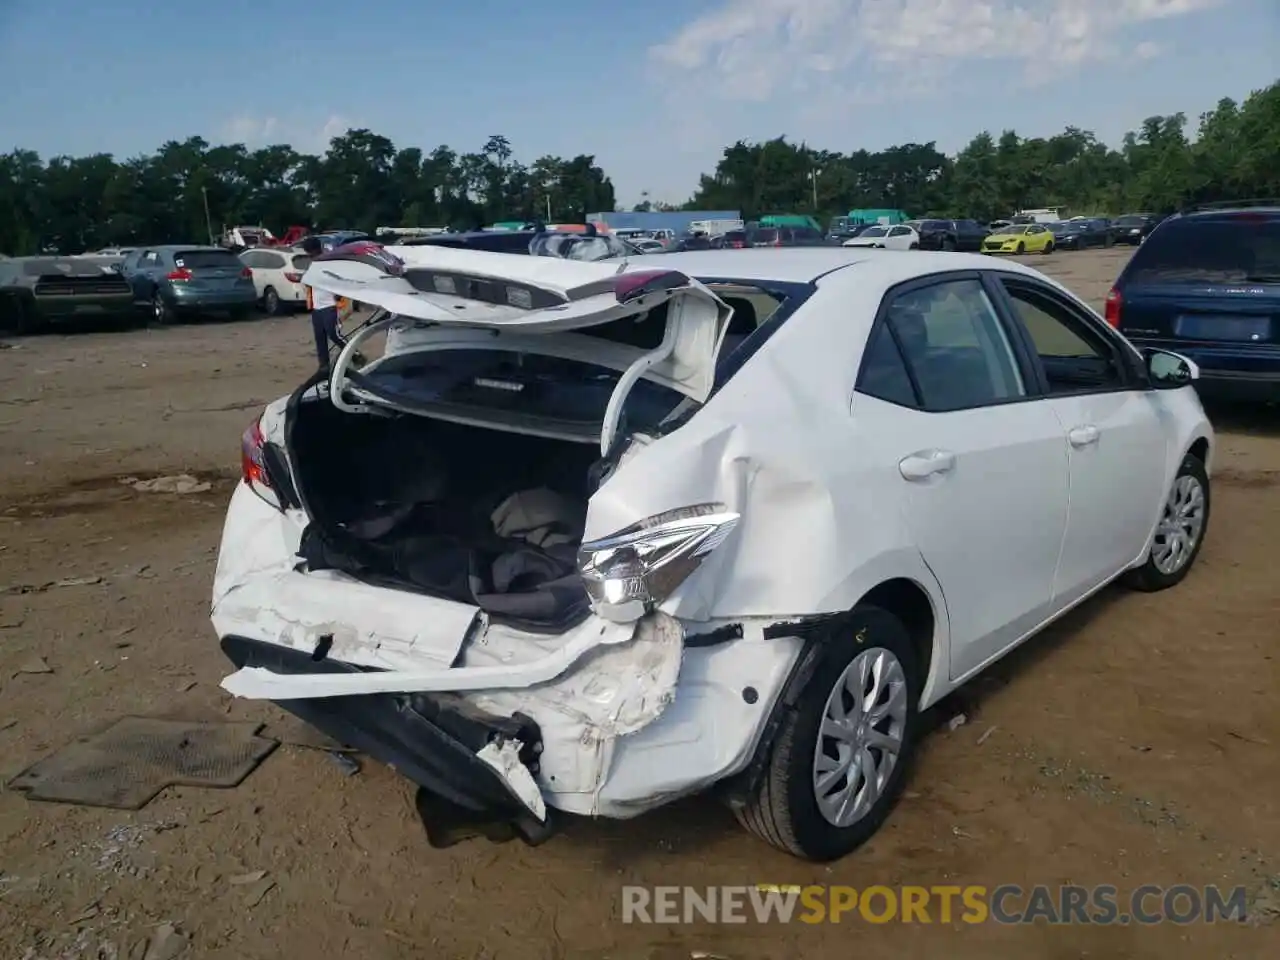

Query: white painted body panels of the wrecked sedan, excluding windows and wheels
[212,247,1212,817]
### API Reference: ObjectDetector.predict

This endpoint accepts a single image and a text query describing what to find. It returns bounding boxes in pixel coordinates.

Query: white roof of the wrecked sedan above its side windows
[627,247,1038,285]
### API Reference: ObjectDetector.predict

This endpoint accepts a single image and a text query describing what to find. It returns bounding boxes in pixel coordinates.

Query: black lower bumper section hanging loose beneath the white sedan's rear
[221,636,552,846]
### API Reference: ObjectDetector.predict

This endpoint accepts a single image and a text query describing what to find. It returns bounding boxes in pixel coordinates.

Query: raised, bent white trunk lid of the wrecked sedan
[302,243,732,412]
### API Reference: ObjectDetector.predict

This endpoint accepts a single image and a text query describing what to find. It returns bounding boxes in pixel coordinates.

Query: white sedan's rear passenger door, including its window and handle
[854,273,1068,680]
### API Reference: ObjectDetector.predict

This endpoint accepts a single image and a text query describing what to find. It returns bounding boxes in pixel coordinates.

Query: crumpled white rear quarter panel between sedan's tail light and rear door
[586,268,946,662]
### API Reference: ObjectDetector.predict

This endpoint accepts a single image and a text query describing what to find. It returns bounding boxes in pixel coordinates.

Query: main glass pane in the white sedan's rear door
[886,279,1025,412]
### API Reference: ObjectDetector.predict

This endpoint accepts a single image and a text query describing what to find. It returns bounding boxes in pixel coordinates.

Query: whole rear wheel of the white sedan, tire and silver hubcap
[736,605,923,861]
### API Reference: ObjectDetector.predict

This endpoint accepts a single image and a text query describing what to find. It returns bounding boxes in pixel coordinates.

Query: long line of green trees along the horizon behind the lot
[0,81,1280,255]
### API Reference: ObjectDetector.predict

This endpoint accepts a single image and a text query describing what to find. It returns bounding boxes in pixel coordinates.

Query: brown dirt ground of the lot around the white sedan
[0,251,1280,960]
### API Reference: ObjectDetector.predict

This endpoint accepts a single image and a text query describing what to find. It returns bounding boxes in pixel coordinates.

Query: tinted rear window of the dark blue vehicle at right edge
[1128,221,1280,283]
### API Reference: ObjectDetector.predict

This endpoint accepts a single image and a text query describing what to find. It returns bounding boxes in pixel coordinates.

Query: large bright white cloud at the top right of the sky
[649,0,1229,102]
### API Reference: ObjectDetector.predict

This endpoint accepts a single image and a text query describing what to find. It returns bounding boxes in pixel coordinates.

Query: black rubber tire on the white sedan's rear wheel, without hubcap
[735,605,923,863]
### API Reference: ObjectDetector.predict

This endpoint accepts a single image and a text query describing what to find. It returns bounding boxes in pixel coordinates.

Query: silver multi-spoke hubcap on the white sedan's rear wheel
[813,648,908,827]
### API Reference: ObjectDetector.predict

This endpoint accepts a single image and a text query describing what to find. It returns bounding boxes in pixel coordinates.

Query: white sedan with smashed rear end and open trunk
[212,244,1213,860]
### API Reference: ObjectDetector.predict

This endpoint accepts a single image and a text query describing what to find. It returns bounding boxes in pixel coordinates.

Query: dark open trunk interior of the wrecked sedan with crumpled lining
[288,399,600,628]
